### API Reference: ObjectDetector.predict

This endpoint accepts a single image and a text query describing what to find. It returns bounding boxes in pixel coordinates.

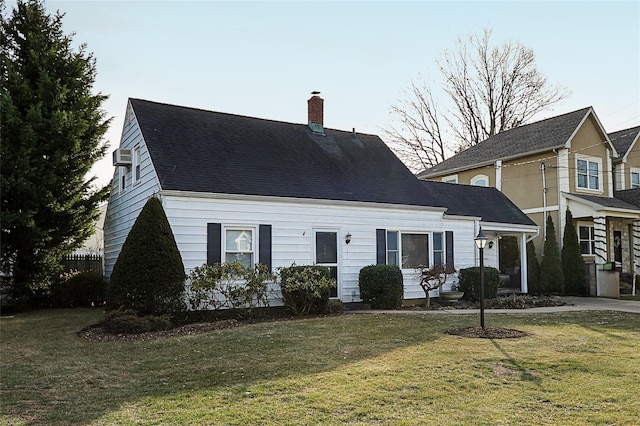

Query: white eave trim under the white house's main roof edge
[160,190,447,214]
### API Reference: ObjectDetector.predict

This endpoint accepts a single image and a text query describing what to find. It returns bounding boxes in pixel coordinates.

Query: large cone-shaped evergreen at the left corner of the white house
[107,197,186,315]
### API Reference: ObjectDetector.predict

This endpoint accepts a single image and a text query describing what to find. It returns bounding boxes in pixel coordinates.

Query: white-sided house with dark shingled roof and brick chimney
[105,96,538,302]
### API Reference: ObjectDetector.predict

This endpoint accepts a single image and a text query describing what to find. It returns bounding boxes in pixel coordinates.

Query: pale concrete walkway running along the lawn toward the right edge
[345,297,640,314]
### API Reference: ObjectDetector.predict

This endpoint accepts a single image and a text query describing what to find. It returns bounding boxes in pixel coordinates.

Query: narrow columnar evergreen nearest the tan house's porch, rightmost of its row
[562,208,587,295]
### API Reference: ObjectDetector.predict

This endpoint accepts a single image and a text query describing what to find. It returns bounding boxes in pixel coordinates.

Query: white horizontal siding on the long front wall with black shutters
[162,192,476,302]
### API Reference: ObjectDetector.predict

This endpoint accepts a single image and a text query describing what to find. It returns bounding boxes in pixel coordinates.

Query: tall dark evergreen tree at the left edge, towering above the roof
[0,0,110,297]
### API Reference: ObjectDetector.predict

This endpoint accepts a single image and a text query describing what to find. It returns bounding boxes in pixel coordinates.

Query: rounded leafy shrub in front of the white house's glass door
[278,265,337,315]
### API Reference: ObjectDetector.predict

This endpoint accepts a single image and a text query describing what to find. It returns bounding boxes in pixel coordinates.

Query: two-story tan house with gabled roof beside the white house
[418,108,640,296]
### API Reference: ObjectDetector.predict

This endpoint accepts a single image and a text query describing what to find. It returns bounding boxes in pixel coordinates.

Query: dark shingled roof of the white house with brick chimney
[130,99,533,225]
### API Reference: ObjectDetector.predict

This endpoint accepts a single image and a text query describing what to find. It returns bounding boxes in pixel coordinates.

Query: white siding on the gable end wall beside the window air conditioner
[104,101,160,279]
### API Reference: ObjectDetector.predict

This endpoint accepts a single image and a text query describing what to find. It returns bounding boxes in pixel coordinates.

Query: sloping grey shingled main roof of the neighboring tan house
[418,107,591,178]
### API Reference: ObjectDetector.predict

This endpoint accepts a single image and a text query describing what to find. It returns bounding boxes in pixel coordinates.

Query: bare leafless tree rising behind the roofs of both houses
[383,29,569,171]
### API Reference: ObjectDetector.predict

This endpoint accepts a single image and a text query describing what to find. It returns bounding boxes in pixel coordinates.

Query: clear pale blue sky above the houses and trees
[11,0,640,184]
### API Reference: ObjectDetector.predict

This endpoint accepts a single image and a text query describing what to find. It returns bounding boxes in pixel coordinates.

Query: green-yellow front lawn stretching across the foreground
[0,309,640,425]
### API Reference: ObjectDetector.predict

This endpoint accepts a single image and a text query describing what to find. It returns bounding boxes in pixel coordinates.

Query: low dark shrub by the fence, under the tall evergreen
[53,271,105,308]
